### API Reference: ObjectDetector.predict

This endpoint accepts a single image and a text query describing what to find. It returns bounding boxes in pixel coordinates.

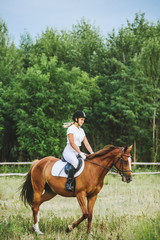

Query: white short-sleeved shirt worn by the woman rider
[67,124,85,147]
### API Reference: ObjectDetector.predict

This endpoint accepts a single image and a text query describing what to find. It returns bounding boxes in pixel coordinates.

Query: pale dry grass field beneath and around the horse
[0,175,160,240]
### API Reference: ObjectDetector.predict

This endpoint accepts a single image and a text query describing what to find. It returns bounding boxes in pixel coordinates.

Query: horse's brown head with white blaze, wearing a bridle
[114,145,132,183]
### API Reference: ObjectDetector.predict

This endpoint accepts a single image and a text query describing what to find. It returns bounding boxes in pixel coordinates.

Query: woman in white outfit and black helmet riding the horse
[63,110,93,192]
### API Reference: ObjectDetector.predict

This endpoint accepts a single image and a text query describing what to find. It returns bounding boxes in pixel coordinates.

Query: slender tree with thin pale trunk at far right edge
[137,36,160,162]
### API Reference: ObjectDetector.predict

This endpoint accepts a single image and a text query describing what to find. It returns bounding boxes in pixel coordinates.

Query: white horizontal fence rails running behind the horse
[0,162,160,177]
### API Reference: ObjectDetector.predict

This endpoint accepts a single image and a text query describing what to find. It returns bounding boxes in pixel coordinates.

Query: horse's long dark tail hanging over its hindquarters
[19,160,39,206]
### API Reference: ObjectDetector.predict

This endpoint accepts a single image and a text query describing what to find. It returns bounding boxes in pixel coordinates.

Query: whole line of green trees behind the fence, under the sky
[0,13,160,162]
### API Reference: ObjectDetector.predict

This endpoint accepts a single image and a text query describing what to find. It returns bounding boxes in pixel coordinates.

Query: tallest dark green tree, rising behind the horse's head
[97,14,158,161]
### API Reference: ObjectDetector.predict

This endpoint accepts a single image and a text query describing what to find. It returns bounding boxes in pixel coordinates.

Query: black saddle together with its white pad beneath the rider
[51,155,84,178]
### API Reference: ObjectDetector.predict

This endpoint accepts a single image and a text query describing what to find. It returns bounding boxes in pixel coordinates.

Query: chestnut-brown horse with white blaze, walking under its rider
[20,145,132,234]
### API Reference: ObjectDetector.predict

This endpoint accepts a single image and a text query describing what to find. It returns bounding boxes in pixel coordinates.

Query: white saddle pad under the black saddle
[51,160,84,178]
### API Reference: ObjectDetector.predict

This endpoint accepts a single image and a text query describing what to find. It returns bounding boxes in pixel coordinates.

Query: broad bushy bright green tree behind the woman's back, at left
[6,54,99,161]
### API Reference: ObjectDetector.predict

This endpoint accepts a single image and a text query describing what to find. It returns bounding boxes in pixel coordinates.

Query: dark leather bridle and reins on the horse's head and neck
[85,149,132,177]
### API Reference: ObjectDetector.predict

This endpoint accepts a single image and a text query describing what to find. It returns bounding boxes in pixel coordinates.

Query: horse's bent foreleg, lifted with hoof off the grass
[67,192,88,232]
